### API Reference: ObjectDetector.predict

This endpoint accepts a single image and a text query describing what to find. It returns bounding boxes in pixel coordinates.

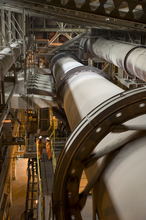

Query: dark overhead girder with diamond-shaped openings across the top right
[3,0,146,33]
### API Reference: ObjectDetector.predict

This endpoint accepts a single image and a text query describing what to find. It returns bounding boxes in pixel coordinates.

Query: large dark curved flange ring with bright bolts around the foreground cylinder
[53,88,146,220]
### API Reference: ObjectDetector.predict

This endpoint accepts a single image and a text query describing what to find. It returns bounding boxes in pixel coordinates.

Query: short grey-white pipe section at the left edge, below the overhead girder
[0,41,23,75]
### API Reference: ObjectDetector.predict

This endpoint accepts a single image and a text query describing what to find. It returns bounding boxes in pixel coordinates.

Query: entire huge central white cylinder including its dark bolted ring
[52,54,146,220]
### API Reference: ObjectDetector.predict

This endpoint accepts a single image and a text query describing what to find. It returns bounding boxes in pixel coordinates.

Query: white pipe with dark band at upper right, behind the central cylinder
[87,38,146,81]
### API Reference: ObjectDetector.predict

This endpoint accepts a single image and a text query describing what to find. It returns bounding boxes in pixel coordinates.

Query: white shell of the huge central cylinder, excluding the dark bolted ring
[52,53,146,220]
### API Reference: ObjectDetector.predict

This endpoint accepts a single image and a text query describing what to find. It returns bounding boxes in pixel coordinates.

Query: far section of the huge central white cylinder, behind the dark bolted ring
[52,54,123,130]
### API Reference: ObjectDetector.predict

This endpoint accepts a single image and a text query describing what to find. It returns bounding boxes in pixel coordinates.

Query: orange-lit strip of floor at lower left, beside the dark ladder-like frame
[11,158,28,220]
